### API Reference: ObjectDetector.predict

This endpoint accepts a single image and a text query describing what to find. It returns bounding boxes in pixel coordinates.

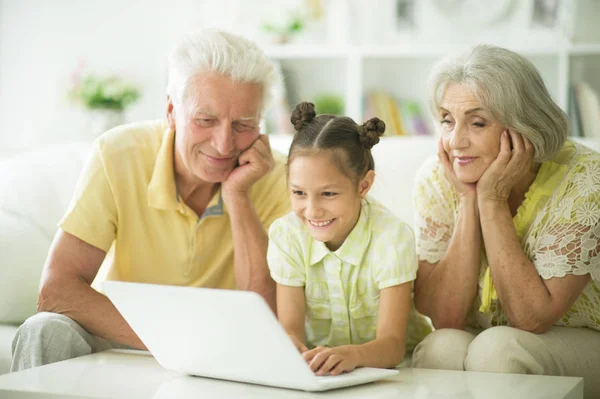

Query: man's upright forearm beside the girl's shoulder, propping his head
[226,195,276,312]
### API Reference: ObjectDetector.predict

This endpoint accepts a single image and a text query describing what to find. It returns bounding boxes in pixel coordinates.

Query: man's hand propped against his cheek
[221,134,275,197]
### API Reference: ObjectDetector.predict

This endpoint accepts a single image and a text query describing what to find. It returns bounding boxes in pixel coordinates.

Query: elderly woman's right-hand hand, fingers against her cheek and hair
[477,129,534,203]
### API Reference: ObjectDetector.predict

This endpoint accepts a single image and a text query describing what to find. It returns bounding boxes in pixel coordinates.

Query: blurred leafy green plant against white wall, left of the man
[69,73,140,111]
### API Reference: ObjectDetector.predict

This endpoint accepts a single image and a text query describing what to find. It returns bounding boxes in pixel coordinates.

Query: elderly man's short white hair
[167,29,279,111]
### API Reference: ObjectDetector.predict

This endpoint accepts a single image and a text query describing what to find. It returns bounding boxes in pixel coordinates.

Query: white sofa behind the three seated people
[0,136,600,374]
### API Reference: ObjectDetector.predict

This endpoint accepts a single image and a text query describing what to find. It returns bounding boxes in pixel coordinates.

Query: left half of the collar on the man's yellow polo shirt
[148,127,180,210]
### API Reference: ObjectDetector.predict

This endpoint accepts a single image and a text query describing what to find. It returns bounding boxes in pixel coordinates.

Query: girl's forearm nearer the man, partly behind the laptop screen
[277,284,308,353]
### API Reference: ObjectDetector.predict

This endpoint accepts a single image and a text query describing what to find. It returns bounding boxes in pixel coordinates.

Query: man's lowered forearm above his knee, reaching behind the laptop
[38,278,146,349]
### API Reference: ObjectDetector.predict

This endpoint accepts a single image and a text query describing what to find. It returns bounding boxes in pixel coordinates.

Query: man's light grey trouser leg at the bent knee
[10,312,132,372]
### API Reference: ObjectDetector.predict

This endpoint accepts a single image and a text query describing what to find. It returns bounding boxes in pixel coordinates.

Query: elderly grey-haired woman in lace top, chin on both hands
[413,46,600,395]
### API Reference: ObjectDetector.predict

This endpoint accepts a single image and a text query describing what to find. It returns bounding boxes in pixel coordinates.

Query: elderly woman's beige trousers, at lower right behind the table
[412,326,600,398]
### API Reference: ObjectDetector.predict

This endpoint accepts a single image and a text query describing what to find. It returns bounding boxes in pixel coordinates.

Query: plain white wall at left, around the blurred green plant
[0,0,176,151]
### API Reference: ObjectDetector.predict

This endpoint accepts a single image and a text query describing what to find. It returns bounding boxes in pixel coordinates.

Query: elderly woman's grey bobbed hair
[428,45,569,162]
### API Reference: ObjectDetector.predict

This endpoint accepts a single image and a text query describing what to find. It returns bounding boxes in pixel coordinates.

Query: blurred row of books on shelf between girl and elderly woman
[363,90,430,136]
